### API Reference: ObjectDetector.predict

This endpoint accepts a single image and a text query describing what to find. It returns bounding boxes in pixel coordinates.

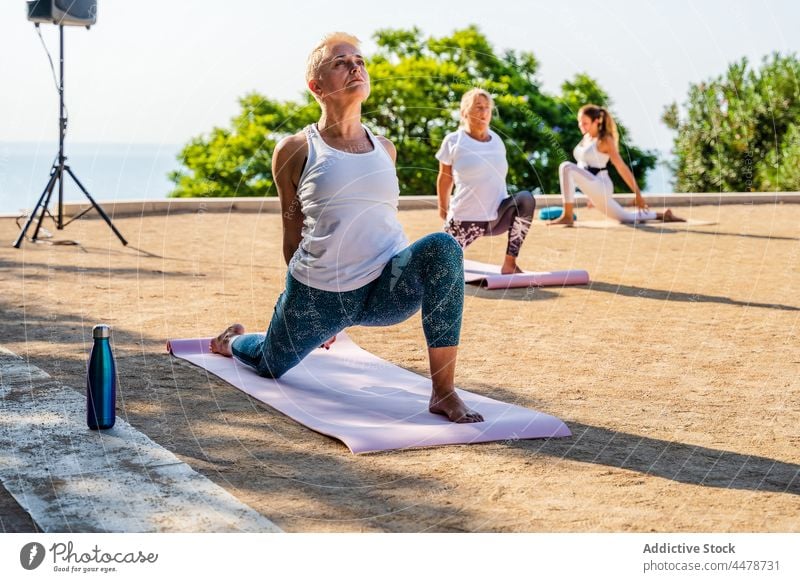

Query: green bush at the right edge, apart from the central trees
[663,53,800,192]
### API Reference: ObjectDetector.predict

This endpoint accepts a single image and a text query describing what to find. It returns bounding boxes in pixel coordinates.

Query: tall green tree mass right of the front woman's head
[364,26,656,194]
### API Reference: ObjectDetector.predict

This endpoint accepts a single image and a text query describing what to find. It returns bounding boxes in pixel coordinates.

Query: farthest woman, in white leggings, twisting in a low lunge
[549,104,683,226]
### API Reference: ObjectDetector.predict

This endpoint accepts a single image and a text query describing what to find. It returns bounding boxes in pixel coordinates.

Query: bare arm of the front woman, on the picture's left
[272,133,308,265]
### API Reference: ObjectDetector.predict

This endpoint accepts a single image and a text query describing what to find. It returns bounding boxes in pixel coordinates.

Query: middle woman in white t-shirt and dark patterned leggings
[436,88,536,274]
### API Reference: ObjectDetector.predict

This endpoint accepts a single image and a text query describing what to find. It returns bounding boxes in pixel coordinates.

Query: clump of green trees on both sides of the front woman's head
[171,26,656,196]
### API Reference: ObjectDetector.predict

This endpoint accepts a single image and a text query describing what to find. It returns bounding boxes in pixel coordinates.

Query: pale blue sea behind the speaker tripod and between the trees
[0,142,673,214]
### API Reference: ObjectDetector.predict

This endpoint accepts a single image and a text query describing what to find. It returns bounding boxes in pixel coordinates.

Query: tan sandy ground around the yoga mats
[0,205,800,532]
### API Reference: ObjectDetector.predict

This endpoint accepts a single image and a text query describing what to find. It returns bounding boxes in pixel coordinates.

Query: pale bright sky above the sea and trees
[0,0,800,150]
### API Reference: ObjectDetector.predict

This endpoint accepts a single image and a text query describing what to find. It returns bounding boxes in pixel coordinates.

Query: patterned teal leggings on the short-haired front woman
[231,232,464,378]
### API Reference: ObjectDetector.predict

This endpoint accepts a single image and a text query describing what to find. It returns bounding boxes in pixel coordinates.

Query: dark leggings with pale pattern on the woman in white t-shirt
[444,190,536,257]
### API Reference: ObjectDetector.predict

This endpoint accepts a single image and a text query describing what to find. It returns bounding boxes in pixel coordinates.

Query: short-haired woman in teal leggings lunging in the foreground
[211,33,483,422]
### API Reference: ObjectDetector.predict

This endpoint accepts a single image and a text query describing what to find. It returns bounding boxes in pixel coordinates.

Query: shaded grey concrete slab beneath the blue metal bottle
[0,348,281,533]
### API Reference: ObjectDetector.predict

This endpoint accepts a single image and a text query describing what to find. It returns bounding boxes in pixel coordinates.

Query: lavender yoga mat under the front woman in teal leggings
[168,332,572,453]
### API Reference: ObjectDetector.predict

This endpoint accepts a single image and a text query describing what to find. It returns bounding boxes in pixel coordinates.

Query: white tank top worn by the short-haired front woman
[289,124,408,292]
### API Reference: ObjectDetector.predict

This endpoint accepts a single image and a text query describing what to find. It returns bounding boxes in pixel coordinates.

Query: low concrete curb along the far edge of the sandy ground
[0,192,800,218]
